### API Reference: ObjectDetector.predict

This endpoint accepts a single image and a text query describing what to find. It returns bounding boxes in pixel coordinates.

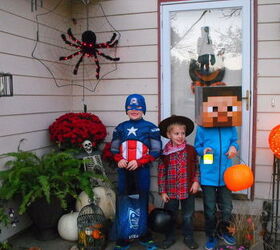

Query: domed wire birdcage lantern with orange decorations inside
[77,203,106,250]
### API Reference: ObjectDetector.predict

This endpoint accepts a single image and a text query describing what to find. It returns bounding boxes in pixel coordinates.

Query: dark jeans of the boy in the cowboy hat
[164,195,195,240]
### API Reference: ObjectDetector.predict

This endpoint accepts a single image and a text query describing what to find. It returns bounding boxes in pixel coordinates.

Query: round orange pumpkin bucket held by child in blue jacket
[224,164,254,191]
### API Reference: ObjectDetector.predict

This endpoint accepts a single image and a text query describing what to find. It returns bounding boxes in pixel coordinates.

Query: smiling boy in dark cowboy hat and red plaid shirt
[158,115,199,249]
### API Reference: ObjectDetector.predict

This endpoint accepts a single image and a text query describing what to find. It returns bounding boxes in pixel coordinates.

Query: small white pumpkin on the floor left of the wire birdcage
[57,212,79,241]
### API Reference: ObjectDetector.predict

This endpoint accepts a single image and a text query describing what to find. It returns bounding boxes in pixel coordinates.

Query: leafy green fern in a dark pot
[0,150,103,240]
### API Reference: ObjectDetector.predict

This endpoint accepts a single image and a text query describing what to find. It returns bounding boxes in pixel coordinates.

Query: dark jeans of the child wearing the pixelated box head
[201,186,233,237]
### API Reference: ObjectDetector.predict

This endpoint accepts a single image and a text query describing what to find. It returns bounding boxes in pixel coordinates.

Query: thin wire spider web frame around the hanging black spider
[31,0,121,92]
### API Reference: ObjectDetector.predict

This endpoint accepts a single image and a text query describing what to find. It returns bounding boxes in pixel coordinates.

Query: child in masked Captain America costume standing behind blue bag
[111,94,161,250]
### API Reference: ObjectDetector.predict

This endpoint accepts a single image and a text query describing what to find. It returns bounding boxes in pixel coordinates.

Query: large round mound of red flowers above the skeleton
[49,113,107,148]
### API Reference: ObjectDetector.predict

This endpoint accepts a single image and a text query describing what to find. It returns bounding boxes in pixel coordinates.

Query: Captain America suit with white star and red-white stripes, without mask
[111,119,161,194]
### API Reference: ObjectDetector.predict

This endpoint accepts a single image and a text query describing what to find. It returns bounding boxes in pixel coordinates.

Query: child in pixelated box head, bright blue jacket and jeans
[194,86,242,250]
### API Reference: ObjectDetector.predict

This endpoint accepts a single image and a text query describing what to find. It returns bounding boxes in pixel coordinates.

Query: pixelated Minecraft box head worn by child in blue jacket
[195,86,242,127]
